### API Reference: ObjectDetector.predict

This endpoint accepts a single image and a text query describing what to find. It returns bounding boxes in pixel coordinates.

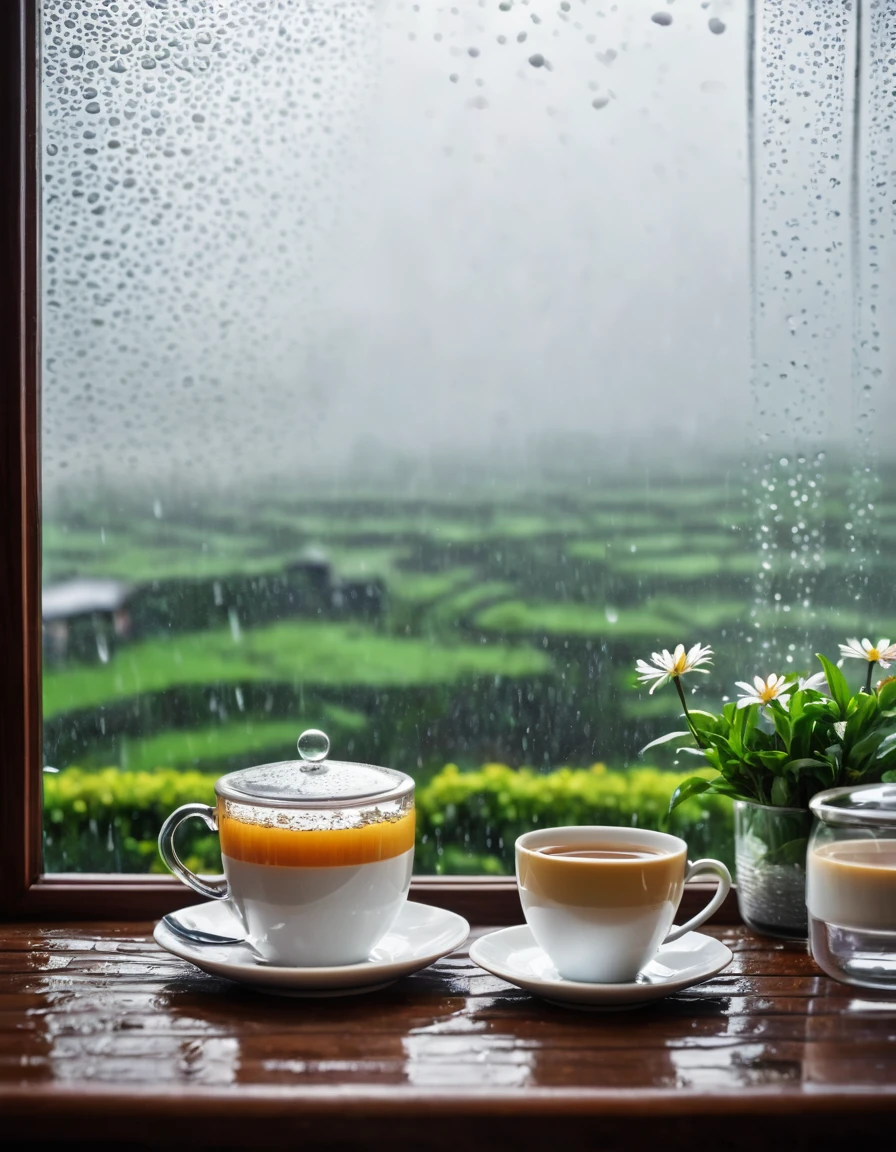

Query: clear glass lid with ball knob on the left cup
[215,728,413,808]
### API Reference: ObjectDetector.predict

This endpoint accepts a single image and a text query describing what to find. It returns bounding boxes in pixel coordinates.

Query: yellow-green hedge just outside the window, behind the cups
[38,764,732,876]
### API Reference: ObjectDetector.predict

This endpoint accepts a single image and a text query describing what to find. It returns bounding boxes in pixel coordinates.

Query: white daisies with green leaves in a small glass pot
[636,639,896,938]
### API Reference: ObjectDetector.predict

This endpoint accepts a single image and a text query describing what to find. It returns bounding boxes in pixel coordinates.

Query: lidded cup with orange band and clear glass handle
[159,729,415,967]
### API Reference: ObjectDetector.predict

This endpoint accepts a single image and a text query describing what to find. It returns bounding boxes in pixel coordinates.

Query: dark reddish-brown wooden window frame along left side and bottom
[0,0,737,924]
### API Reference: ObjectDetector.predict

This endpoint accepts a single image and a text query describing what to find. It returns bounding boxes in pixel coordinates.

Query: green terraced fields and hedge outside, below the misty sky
[44,467,896,873]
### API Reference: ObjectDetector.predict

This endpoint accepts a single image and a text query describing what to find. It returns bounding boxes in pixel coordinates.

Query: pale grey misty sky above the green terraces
[43,0,894,502]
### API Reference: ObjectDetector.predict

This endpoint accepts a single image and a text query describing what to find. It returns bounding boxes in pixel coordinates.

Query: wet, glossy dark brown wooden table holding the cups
[0,924,896,1152]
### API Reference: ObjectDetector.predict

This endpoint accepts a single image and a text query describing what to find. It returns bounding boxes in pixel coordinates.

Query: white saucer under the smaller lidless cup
[470,924,731,1009]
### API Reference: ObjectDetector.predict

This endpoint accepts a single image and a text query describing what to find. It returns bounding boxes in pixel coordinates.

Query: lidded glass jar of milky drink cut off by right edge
[806,783,896,991]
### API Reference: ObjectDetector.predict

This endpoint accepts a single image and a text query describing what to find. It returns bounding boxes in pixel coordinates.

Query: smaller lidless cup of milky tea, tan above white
[516,825,731,984]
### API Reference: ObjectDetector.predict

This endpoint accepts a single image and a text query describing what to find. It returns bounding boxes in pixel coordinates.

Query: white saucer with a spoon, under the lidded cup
[152,900,470,996]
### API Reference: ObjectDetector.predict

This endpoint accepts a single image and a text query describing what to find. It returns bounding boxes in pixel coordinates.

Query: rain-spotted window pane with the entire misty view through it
[40,0,896,873]
